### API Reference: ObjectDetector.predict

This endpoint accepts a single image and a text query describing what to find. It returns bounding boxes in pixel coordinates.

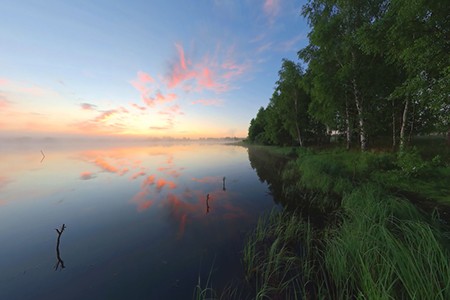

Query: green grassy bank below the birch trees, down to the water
[243,142,450,299]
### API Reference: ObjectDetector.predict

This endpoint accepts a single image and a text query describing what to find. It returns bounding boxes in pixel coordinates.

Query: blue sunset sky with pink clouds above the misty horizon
[0,0,309,138]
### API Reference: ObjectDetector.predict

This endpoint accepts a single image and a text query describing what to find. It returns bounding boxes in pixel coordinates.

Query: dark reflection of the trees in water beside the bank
[247,147,289,204]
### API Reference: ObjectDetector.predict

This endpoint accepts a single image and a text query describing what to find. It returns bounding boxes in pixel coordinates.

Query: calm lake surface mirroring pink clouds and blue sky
[0,143,275,299]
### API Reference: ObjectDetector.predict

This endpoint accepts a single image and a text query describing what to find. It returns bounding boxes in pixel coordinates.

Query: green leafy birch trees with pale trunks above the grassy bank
[248,0,450,150]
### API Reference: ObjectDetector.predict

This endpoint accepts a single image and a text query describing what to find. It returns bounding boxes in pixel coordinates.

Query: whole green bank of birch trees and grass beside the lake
[243,0,450,299]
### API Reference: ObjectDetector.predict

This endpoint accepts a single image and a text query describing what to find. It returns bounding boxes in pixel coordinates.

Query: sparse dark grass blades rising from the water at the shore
[243,211,313,299]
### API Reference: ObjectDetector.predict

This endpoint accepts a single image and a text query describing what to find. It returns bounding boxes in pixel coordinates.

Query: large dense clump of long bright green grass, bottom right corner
[324,186,450,299]
